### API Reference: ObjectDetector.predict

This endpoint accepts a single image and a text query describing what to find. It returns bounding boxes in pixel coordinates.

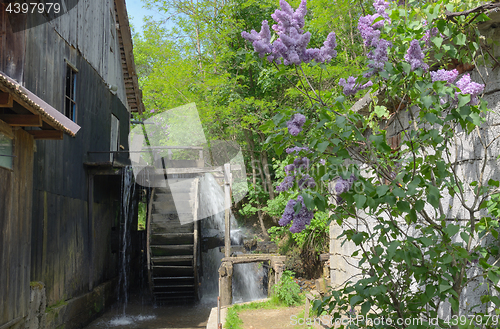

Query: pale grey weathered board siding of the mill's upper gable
[48,0,127,109]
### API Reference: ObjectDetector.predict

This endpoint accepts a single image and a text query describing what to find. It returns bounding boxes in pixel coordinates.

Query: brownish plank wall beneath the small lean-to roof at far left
[0,129,34,326]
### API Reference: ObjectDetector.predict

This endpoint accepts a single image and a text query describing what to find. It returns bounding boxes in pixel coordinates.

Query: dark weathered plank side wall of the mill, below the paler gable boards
[24,11,129,305]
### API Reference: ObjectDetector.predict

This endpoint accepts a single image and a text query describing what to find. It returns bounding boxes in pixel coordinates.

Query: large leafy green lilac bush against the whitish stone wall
[239,0,500,328]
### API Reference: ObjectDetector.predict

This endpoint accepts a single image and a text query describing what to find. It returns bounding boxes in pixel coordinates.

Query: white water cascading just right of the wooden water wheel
[199,174,266,302]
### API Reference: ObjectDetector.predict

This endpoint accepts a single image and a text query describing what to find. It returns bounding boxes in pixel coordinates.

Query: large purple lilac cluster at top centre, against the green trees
[241,0,337,65]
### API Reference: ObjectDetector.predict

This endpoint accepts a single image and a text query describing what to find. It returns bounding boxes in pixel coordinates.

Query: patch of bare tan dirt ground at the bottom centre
[238,306,328,329]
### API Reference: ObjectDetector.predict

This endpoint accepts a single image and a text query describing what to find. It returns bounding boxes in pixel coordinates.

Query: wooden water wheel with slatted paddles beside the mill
[147,175,199,302]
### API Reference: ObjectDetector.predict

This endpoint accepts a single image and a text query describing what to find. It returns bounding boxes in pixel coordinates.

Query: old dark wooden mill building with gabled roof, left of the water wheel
[0,0,143,329]
